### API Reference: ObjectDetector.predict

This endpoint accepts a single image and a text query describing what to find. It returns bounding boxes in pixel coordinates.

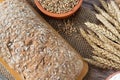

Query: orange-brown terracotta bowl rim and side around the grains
[34,0,83,19]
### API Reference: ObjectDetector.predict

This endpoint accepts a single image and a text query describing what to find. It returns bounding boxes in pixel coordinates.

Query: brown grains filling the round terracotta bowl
[38,0,79,14]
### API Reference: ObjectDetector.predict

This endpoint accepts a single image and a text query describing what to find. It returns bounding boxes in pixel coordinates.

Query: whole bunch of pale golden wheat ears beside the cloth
[80,0,120,69]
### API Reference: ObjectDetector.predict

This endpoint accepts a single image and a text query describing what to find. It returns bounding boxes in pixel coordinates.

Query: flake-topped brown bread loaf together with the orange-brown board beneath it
[0,0,88,80]
